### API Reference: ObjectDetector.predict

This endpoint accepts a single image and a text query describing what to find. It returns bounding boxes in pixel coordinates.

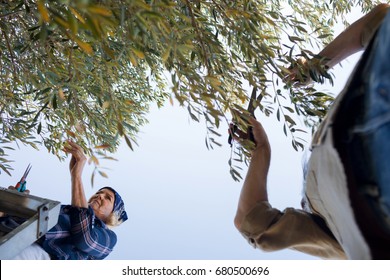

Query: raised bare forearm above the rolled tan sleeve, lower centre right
[234,118,271,230]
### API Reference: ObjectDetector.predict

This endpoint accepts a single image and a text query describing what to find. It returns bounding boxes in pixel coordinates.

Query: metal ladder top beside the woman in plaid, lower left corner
[0,187,61,260]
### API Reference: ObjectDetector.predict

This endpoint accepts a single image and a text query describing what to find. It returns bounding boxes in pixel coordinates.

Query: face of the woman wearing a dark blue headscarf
[88,189,115,222]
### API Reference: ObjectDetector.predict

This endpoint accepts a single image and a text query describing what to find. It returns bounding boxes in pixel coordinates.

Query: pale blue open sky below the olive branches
[0,7,366,260]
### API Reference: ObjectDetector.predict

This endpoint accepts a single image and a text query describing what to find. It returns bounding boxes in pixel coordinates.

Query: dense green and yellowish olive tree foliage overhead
[0,0,384,179]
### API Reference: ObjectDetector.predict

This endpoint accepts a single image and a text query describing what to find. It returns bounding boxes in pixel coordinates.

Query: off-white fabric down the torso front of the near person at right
[306,76,371,260]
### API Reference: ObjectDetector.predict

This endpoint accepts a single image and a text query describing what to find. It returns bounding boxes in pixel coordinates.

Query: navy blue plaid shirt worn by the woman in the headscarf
[40,205,117,260]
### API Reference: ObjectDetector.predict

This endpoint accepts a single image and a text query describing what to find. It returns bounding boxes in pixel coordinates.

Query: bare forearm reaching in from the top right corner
[319,4,389,68]
